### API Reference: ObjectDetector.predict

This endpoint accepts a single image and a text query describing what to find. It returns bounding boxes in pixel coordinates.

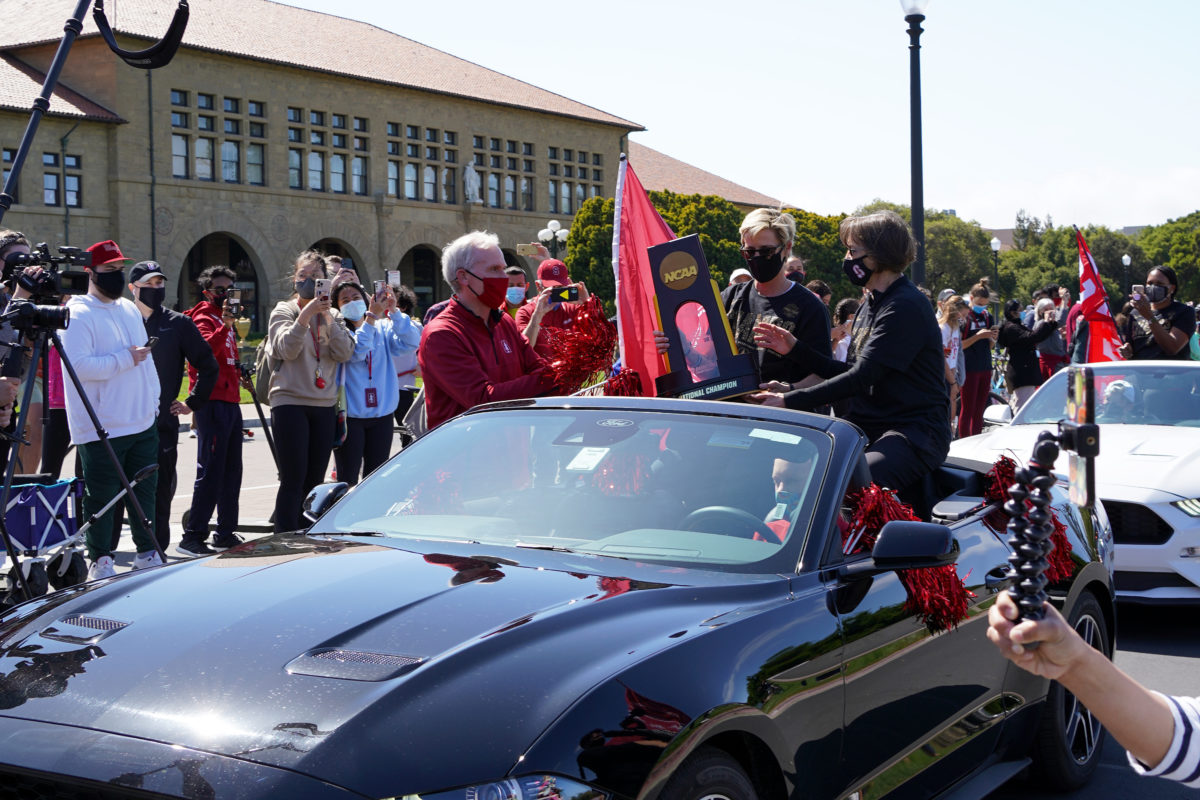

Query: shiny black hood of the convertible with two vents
[0,536,787,796]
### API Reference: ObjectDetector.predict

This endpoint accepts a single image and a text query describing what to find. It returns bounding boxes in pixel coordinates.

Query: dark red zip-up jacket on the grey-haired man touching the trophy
[416,299,556,428]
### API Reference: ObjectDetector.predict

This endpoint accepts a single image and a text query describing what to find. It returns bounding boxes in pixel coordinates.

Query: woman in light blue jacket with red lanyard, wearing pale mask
[334,283,416,486]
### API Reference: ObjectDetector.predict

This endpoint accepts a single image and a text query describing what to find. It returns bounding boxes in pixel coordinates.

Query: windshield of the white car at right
[1013,361,1200,428]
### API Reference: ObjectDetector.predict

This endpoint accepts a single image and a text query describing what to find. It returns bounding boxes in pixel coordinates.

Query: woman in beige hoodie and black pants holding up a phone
[266,251,354,531]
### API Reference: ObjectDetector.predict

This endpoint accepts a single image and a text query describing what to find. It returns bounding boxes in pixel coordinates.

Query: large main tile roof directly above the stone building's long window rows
[0,0,642,131]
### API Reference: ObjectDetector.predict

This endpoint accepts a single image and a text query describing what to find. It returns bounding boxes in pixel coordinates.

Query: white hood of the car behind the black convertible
[950,425,1200,498]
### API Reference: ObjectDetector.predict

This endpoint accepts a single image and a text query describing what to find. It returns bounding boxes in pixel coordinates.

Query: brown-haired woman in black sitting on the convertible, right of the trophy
[750,211,950,501]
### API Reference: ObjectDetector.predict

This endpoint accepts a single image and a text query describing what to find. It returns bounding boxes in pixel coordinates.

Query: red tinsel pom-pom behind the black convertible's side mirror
[842,483,974,633]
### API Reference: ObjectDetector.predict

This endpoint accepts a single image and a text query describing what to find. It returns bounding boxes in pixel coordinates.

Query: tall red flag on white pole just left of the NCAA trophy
[612,155,676,397]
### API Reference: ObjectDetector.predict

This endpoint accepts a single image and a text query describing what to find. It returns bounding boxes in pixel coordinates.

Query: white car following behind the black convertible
[950,361,1200,603]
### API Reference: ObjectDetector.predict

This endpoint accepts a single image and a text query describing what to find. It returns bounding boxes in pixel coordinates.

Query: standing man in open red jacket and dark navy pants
[176,266,241,555]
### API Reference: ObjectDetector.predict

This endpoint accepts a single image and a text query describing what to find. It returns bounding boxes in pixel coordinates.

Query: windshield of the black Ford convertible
[312,408,832,565]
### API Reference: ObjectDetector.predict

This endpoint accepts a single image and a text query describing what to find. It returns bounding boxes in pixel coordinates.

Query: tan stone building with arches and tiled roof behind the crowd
[0,0,642,329]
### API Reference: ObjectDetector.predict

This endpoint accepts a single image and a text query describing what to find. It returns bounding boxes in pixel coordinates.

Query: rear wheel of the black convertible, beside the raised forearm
[1032,591,1112,792]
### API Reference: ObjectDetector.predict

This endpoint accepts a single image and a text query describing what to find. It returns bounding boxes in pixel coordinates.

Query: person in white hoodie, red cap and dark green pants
[61,241,162,581]
